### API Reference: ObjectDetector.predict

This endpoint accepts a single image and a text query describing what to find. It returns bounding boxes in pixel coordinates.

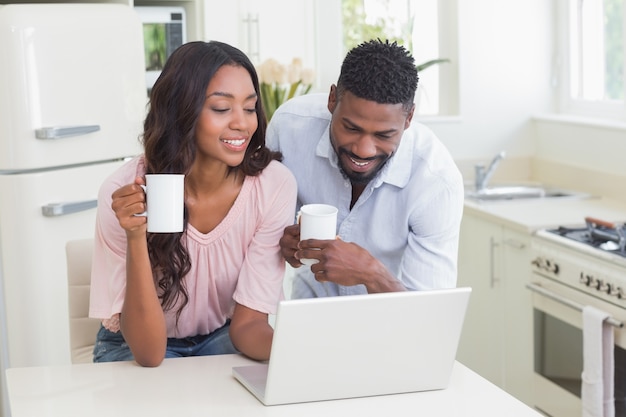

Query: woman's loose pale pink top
[89,157,296,338]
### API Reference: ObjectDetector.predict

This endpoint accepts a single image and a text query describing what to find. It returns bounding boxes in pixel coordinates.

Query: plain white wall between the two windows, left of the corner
[425,0,552,160]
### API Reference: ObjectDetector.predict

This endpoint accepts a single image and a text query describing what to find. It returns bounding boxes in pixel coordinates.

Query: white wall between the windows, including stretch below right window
[425,0,626,200]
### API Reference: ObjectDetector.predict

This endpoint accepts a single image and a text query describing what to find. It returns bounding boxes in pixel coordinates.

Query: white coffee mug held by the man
[300,204,338,265]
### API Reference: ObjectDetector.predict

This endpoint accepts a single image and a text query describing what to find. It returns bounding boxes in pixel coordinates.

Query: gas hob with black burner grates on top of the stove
[547,217,626,258]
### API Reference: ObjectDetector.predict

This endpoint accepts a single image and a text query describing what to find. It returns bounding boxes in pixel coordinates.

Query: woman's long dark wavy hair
[142,41,282,320]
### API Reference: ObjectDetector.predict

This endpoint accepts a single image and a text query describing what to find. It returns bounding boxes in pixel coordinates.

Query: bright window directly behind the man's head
[318,0,459,116]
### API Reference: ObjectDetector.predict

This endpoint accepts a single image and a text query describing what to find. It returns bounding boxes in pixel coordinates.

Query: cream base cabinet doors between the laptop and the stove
[457,213,533,405]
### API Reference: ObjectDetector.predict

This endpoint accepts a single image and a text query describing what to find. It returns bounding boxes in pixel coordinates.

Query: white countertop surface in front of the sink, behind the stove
[465,196,626,233]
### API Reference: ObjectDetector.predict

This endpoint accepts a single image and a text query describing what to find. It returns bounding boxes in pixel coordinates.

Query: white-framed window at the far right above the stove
[555,0,626,122]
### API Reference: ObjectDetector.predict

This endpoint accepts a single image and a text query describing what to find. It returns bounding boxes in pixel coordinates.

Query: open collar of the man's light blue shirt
[315,124,415,188]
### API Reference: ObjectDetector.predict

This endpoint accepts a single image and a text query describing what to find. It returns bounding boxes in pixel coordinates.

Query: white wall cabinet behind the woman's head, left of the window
[202,0,344,93]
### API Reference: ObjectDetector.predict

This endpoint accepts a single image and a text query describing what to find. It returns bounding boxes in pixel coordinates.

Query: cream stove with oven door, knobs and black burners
[527,223,626,417]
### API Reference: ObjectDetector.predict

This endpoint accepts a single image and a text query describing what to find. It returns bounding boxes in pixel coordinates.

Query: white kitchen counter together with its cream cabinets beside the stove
[457,186,626,415]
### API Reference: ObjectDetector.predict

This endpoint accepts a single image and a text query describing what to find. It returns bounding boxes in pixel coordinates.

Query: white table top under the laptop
[7,355,540,417]
